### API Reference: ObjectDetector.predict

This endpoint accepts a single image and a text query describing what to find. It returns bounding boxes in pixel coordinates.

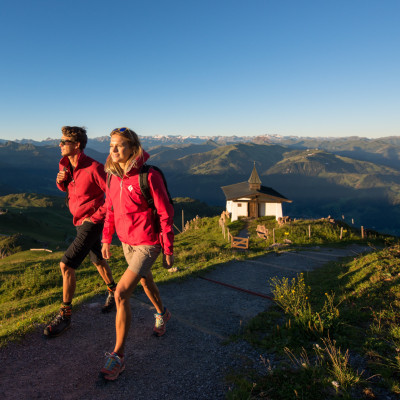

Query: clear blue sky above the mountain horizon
[0,0,400,140]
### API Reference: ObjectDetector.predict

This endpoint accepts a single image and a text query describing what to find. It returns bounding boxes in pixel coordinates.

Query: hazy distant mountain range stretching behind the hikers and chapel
[0,135,400,234]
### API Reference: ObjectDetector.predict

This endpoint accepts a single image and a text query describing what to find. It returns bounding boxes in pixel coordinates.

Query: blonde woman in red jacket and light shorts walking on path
[101,128,174,380]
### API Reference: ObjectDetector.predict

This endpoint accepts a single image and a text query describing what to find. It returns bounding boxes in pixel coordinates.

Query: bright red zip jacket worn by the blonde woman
[103,152,174,255]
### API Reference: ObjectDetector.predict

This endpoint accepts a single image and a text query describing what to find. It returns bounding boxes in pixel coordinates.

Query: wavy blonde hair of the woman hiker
[104,128,143,178]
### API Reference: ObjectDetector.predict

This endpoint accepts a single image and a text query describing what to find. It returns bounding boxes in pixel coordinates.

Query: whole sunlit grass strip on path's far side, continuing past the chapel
[0,217,388,343]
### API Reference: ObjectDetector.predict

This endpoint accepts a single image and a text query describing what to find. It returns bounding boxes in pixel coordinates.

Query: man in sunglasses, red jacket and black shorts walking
[44,126,117,337]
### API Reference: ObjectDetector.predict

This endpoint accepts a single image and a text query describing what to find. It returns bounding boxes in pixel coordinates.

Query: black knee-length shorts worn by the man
[61,221,104,269]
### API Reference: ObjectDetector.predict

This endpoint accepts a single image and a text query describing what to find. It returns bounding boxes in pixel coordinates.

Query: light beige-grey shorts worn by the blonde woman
[122,243,161,277]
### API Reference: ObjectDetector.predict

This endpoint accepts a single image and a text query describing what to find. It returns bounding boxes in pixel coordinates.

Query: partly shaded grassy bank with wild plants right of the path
[228,244,400,400]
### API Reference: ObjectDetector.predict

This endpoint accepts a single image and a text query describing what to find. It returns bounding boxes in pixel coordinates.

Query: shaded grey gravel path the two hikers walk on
[0,245,368,400]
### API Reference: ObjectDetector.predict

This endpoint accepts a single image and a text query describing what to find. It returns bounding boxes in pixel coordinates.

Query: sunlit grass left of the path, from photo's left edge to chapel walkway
[0,217,266,345]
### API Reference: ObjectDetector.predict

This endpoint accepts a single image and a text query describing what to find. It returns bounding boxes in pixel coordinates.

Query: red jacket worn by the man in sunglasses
[57,153,106,226]
